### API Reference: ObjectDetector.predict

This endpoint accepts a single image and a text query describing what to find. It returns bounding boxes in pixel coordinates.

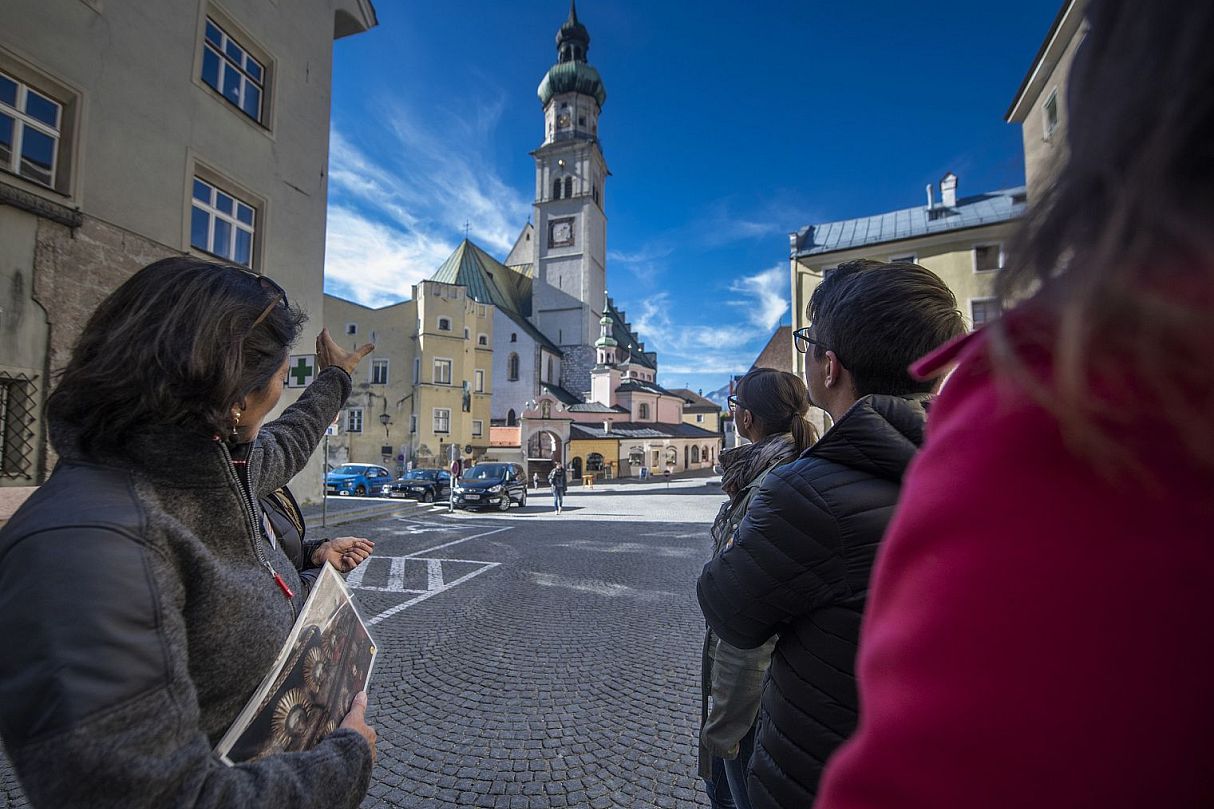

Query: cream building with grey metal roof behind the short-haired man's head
[789,172,1025,429]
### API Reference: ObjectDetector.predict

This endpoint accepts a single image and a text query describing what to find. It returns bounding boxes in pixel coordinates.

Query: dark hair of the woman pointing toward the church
[47,258,306,453]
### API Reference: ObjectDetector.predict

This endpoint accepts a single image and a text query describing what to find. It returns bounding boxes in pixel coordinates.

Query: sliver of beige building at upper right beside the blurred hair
[1004,0,1088,200]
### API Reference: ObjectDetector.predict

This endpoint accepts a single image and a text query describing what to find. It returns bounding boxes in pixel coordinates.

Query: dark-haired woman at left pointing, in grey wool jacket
[0,258,375,809]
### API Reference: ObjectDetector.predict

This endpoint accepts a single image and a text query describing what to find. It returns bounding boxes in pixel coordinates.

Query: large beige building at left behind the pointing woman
[0,0,376,490]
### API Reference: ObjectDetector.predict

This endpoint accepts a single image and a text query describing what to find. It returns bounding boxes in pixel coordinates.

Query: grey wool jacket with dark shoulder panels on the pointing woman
[0,368,371,809]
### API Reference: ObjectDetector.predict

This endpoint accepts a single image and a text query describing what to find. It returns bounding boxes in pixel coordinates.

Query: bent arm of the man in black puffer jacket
[696,464,845,649]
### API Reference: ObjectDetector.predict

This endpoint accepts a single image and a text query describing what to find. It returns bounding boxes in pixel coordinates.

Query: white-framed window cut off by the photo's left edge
[0,73,63,188]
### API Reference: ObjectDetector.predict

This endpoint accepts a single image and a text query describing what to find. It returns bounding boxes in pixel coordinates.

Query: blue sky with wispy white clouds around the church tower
[325,0,1059,391]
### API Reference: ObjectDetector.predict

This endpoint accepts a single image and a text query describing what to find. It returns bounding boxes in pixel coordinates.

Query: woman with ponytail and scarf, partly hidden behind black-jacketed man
[699,368,817,809]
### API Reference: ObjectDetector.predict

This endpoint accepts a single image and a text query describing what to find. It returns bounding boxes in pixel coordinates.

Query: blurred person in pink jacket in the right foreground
[815,0,1214,809]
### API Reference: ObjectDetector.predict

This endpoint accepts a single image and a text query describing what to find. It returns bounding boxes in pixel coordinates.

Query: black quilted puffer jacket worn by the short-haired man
[697,396,924,809]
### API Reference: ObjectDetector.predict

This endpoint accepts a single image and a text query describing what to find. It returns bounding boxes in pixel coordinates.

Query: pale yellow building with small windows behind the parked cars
[324,281,494,471]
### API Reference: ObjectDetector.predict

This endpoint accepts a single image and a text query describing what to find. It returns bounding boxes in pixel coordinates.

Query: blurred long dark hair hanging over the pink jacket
[992,0,1214,466]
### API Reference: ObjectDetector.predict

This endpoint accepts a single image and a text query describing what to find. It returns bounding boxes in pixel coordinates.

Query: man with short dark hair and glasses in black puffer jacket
[697,261,965,809]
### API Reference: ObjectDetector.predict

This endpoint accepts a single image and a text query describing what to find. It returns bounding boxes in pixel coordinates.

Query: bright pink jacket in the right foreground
[815,323,1214,809]
